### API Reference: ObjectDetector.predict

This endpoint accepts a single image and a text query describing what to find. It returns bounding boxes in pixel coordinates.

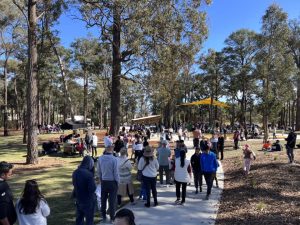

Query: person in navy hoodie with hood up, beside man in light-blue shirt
[72,156,96,225]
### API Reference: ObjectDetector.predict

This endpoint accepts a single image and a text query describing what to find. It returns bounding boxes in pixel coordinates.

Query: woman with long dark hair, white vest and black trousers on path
[174,151,191,205]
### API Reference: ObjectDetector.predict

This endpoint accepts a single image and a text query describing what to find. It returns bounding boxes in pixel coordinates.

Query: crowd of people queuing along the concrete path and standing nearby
[0,123,297,225]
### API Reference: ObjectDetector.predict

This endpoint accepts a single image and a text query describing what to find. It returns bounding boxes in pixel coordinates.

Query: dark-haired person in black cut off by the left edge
[0,161,17,225]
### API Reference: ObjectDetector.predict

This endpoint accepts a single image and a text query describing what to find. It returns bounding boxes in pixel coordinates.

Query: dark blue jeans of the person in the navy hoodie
[76,201,95,225]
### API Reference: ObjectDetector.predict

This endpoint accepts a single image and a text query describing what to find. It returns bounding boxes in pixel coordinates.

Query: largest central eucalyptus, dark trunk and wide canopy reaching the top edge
[77,0,210,134]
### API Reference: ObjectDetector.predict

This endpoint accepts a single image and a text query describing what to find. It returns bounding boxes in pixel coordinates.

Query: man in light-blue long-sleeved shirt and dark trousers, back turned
[97,146,120,222]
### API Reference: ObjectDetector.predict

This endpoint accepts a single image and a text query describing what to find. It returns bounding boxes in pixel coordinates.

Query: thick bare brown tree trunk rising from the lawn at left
[26,0,38,164]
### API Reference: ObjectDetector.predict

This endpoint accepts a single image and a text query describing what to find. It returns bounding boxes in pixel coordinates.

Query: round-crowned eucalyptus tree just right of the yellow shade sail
[223,29,258,126]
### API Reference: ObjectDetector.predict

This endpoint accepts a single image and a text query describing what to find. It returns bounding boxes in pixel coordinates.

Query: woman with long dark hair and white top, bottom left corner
[16,180,50,225]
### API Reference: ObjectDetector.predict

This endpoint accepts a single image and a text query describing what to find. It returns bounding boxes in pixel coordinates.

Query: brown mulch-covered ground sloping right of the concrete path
[216,146,300,225]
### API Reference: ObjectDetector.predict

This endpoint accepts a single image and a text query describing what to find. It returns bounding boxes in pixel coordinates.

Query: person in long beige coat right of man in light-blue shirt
[118,147,134,205]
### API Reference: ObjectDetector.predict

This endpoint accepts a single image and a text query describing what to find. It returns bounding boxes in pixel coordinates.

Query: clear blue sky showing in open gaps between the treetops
[56,0,300,51]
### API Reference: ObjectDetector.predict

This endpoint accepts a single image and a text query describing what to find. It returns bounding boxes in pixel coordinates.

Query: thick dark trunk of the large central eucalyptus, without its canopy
[110,2,121,135]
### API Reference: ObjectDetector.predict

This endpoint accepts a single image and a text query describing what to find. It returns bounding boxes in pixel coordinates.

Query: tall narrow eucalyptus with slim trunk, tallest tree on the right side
[256,4,294,140]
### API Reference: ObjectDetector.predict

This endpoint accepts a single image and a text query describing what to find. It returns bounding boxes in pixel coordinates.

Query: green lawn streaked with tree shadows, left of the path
[0,131,99,225]
